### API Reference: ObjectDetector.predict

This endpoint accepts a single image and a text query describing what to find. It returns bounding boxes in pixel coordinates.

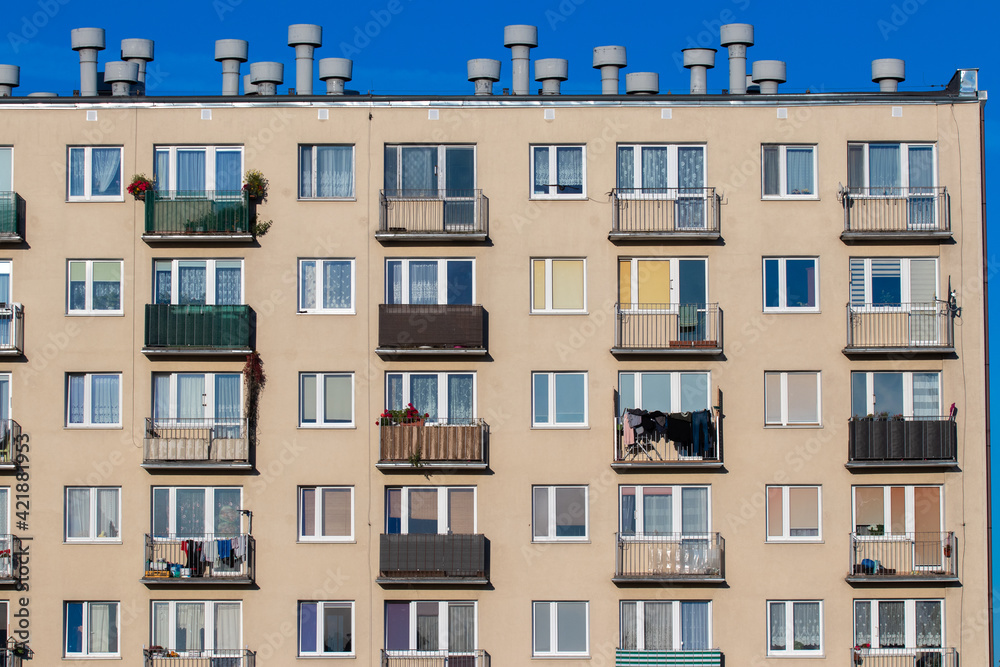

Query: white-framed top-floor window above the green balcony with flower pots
[153,146,243,193]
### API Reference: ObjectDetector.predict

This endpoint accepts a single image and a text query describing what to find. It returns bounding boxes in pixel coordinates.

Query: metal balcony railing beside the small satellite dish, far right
[844,301,955,354]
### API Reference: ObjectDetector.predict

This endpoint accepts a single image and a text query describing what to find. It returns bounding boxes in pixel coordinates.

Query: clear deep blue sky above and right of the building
[0,0,1000,656]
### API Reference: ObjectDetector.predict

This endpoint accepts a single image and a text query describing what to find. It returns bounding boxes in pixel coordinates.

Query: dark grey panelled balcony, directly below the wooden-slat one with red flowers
[376,534,490,585]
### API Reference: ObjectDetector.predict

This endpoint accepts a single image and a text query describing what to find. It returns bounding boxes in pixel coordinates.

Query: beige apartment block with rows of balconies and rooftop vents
[0,20,992,667]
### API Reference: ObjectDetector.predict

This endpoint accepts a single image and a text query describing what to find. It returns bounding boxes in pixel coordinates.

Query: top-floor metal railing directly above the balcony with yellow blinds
[608,188,720,240]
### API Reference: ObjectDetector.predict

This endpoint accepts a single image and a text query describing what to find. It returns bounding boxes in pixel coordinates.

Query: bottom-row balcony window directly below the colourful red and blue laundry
[150,600,243,658]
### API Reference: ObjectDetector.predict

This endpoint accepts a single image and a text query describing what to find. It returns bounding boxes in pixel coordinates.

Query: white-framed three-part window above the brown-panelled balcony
[385,259,476,305]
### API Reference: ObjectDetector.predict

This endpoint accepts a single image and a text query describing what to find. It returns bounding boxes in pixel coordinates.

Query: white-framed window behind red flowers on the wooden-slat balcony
[385,373,476,424]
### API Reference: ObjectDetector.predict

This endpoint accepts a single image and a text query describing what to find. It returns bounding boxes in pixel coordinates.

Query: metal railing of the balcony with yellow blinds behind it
[611,303,722,355]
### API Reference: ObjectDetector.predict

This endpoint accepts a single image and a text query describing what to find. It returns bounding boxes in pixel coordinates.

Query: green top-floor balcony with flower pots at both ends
[142,190,253,242]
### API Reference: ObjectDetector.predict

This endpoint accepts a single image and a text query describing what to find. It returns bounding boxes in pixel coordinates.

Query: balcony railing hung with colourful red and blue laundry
[142,533,256,585]
